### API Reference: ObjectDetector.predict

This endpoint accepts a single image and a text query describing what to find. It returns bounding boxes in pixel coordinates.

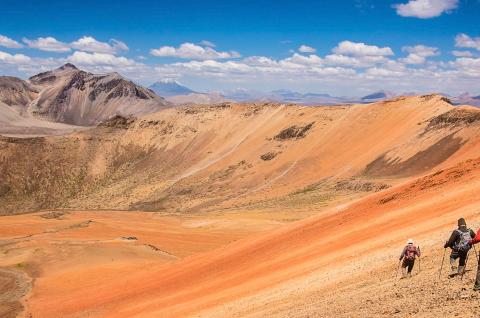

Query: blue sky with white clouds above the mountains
[0,0,480,95]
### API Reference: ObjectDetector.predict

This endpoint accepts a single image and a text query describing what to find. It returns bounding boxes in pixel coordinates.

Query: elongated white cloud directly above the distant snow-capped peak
[150,43,240,60]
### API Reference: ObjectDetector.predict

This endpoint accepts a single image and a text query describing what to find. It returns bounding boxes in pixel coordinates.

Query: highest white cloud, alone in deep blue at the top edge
[393,0,458,19]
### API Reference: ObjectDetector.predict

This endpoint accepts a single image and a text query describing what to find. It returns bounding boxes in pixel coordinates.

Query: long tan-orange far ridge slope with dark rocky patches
[0,95,480,214]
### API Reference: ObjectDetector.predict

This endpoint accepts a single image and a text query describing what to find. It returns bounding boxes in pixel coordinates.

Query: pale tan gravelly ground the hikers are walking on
[204,231,480,318]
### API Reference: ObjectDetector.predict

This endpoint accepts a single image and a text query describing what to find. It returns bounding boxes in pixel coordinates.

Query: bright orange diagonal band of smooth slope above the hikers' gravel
[23,159,480,317]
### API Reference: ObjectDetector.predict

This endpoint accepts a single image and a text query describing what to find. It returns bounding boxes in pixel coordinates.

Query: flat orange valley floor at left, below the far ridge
[0,211,284,317]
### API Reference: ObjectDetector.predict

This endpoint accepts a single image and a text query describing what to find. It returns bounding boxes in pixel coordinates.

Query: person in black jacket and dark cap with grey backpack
[443,218,475,277]
